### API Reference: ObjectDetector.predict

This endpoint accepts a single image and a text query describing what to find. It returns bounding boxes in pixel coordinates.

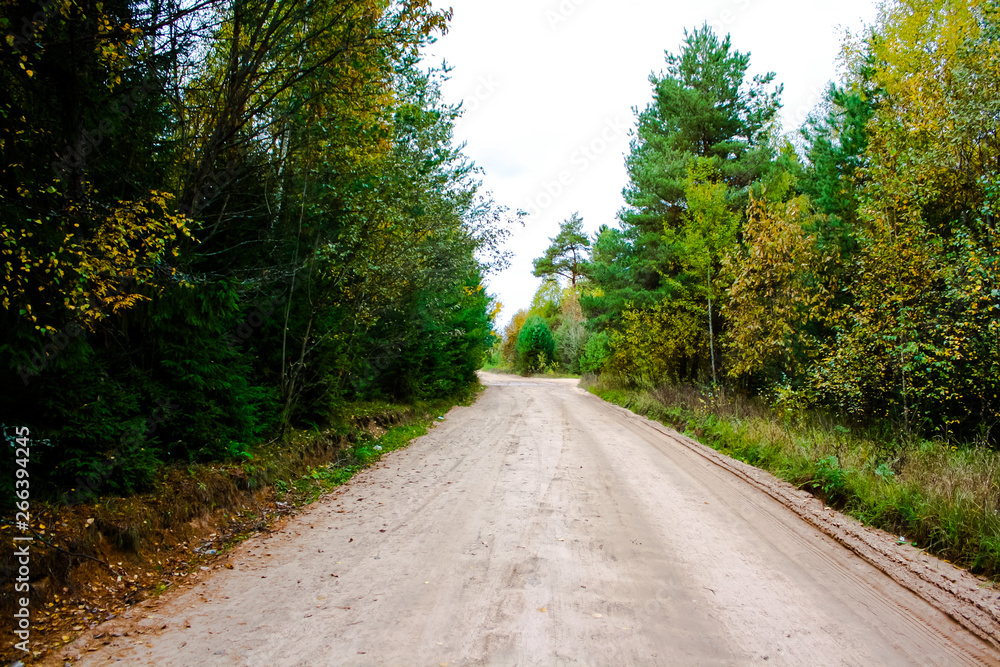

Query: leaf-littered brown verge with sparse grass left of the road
[0,385,482,664]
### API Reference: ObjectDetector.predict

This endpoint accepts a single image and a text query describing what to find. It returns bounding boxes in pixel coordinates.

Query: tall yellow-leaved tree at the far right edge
[815,0,1000,441]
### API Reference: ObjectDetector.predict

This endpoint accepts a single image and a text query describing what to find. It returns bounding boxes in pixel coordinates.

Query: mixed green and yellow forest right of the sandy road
[492,0,1000,447]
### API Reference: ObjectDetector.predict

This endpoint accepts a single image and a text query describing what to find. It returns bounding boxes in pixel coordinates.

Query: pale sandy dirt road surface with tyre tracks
[70,374,998,666]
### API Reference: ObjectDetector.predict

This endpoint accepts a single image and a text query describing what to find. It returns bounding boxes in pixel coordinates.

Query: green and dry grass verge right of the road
[583,376,1000,582]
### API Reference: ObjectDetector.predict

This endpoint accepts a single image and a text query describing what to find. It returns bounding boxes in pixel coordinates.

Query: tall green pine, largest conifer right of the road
[583,25,781,381]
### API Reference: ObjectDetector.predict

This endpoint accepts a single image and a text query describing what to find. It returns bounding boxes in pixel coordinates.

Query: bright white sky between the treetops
[426,0,877,326]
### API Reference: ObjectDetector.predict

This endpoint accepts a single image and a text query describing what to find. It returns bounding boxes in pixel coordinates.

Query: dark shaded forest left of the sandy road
[0,0,508,503]
